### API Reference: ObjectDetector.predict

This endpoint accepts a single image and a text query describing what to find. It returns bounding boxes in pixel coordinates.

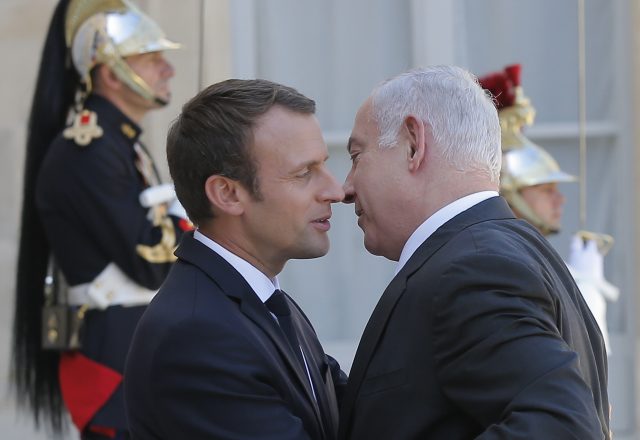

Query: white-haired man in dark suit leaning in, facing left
[339,66,610,440]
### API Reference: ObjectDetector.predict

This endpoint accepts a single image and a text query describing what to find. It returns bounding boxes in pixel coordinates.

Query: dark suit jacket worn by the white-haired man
[339,197,609,440]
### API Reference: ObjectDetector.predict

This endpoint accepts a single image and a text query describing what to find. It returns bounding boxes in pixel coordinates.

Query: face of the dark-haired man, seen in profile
[242,106,344,273]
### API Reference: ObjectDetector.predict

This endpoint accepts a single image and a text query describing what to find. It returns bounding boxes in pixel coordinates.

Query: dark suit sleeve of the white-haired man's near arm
[433,255,603,440]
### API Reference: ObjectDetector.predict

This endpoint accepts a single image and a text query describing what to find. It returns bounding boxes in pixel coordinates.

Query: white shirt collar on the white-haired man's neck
[396,191,498,274]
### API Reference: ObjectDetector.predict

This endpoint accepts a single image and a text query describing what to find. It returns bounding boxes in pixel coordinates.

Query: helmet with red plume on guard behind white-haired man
[478,64,576,234]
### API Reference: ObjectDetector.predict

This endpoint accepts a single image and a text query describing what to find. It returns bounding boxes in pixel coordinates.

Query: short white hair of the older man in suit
[371,66,502,182]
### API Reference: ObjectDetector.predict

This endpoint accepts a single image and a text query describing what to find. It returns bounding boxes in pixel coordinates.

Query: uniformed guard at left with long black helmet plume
[13,0,188,438]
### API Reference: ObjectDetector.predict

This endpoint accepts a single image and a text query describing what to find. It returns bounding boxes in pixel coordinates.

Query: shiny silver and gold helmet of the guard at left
[65,0,180,104]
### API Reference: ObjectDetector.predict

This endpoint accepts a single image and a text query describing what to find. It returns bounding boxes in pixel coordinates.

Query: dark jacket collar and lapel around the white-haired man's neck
[338,197,514,438]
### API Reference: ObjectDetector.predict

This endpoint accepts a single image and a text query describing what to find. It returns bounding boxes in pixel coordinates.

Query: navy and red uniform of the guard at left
[36,95,188,431]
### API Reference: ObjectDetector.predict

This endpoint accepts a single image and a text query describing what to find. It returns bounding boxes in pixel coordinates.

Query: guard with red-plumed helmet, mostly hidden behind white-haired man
[479,64,619,352]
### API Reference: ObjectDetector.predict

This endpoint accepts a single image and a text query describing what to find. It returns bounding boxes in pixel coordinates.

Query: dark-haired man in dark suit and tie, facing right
[125,80,346,439]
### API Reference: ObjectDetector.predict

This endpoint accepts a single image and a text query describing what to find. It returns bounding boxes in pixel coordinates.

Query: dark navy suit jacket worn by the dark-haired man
[124,233,346,440]
